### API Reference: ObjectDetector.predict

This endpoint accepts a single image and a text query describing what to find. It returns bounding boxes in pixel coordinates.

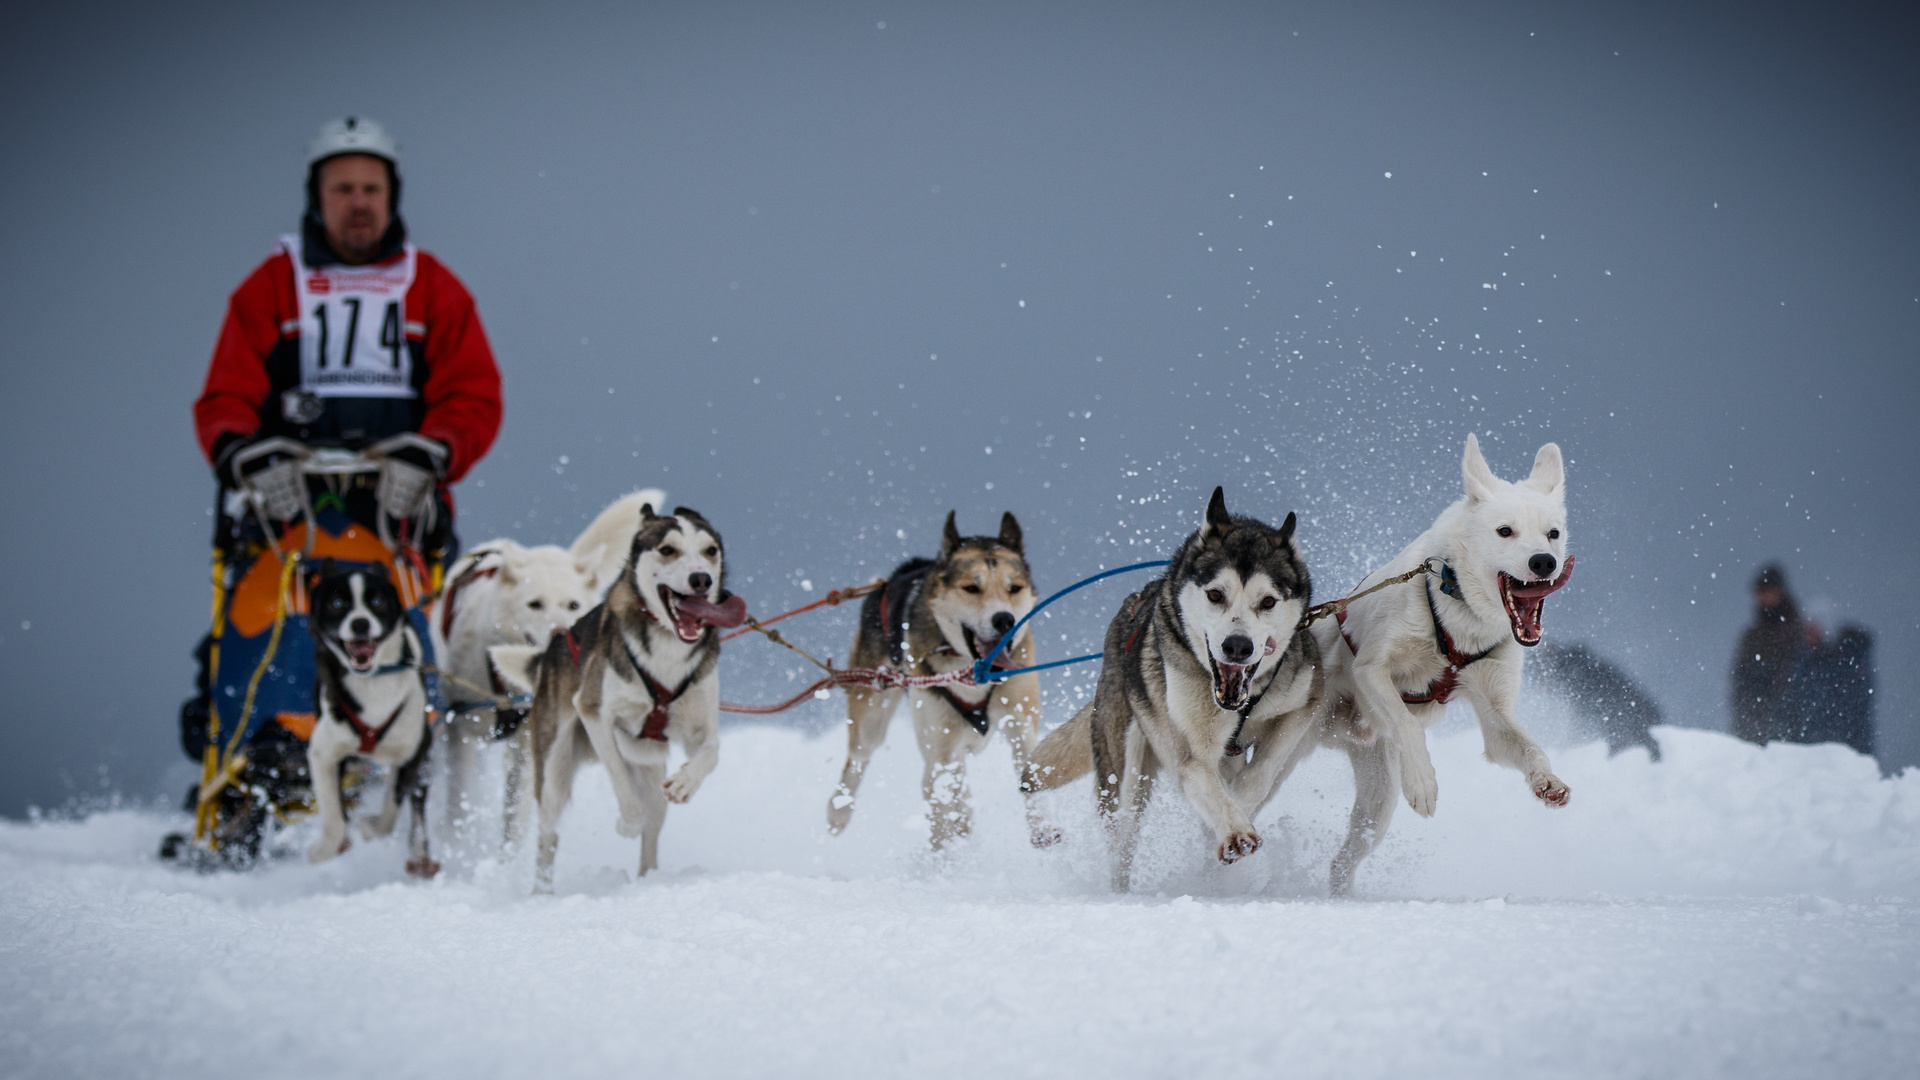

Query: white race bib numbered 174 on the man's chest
[280,236,417,398]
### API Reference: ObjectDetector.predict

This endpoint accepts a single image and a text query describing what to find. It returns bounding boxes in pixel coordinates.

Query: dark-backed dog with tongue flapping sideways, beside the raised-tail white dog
[492,505,747,890]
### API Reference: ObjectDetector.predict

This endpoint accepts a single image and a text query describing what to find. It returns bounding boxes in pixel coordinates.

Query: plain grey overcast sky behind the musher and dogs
[0,2,1920,815]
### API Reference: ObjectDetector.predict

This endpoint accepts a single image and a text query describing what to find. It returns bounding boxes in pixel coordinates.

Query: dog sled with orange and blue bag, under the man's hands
[172,434,451,867]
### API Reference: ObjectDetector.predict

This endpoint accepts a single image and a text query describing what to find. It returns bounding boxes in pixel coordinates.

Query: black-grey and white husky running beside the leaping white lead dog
[1027,488,1321,890]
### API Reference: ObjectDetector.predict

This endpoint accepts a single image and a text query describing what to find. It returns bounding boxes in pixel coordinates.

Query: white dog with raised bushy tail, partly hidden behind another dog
[428,488,666,847]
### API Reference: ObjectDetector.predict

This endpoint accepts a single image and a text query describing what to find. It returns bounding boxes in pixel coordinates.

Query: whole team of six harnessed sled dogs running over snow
[309,434,1572,896]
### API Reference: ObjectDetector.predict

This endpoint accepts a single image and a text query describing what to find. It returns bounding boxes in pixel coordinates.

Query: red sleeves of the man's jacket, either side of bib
[194,250,499,484]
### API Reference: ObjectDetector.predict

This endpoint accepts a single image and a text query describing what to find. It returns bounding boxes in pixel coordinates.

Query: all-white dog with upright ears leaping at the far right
[1313,434,1572,896]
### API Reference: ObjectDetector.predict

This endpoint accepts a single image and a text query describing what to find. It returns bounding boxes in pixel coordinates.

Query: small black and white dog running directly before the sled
[307,559,440,878]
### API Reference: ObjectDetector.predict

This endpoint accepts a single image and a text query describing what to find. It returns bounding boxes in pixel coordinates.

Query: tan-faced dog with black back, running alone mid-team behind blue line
[828,513,1058,847]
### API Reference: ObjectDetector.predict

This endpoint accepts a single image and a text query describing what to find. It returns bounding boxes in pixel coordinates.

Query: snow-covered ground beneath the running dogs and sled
[0,724,1920,1078]
